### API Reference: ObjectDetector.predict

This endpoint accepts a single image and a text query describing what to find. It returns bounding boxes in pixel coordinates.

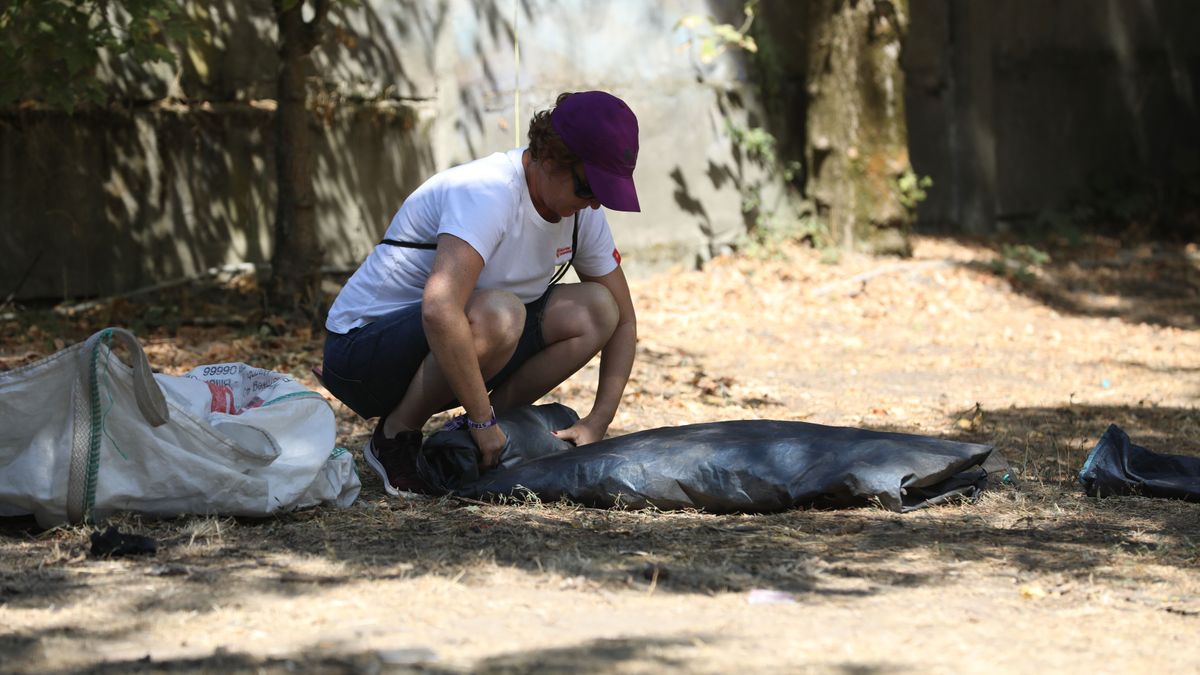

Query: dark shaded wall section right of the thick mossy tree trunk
[902,0,1200,233]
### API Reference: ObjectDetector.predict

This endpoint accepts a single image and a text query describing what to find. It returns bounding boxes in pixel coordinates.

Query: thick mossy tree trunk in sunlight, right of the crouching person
[805,0,914,255]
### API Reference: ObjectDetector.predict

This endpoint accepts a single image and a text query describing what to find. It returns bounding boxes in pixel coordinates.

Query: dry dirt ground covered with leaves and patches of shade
[0,238,1200,674]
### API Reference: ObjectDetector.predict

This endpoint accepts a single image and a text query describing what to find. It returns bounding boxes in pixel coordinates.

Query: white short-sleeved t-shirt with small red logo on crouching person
[325,148,620,333]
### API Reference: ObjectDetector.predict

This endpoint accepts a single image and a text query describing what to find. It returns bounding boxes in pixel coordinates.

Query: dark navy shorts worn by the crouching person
[322,287,553,418]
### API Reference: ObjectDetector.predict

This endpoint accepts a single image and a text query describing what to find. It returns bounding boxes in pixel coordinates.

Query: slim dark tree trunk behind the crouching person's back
[268,0,328,316]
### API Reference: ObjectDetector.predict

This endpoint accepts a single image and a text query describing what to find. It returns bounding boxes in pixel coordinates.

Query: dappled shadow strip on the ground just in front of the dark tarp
[0,406,1200,629]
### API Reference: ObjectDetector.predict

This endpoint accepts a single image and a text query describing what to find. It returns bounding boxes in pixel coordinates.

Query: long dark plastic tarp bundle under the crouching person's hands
[418,404,1003,513]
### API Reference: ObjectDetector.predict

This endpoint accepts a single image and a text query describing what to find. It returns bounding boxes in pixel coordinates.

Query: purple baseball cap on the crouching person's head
[550,91,642,211]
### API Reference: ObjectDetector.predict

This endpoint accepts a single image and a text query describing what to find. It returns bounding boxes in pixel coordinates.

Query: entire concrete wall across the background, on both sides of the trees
[7,0,1200,298]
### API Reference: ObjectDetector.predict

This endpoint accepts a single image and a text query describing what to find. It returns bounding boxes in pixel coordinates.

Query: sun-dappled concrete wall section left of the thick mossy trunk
[0,0,757,298]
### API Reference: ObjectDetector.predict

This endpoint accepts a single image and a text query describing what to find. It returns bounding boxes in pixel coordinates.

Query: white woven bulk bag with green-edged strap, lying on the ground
[0,328,360,527]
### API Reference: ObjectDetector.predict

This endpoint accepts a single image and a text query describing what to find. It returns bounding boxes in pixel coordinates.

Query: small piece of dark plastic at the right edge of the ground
[1079,424,1200,502]
